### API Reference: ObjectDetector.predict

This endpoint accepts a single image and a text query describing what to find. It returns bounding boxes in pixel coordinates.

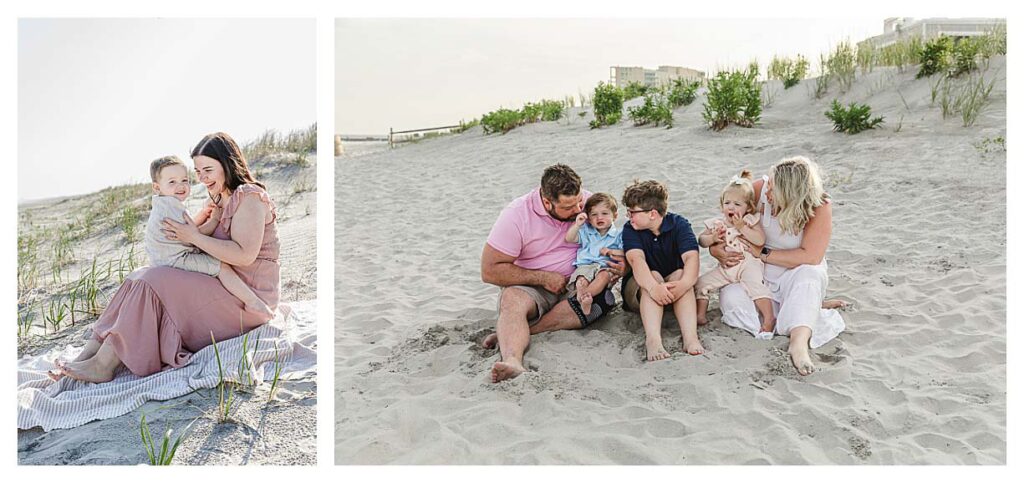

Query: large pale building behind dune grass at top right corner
[857,16,1007,47]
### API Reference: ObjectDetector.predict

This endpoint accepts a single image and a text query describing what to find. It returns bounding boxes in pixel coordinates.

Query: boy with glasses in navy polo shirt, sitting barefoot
[623,181,705,360]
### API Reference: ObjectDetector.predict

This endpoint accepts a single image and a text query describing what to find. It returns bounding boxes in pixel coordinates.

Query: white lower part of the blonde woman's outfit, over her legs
[719,261,846,348]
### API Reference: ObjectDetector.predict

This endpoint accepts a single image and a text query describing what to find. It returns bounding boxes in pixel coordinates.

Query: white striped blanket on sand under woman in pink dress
[17,301,316,431]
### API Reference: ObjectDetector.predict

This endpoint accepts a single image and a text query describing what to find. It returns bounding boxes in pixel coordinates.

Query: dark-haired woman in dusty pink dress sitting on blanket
[58,132,281,383]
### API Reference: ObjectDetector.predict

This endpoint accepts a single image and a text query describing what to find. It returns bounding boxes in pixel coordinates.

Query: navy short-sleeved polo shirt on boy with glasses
[623,213,698,276]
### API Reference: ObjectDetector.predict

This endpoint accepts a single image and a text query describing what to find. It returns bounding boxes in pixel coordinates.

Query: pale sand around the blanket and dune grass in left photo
[17,149,316,465]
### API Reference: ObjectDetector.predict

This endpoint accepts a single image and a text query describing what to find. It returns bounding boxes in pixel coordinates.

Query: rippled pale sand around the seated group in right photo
[333,56,1007,465]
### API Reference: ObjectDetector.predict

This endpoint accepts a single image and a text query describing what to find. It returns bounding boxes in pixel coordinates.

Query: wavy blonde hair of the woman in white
[768,156,828,234]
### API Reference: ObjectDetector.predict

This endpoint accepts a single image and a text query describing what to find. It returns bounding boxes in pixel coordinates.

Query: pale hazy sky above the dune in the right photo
[335,16,884,134]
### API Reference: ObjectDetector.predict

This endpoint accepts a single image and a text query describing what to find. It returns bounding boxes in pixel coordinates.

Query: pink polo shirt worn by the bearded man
[487,188,590,276]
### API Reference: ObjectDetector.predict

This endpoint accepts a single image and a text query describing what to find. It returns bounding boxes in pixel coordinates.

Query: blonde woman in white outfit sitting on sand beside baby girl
[711,156,846,376]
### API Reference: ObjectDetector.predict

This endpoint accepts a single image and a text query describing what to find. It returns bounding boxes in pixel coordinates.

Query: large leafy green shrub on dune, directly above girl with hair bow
[703,70,761,131]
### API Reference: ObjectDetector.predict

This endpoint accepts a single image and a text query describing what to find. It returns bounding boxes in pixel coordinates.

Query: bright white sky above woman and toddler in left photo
[17,18,316,201]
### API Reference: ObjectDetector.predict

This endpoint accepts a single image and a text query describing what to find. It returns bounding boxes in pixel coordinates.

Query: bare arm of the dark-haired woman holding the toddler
[163,195,268,267]
